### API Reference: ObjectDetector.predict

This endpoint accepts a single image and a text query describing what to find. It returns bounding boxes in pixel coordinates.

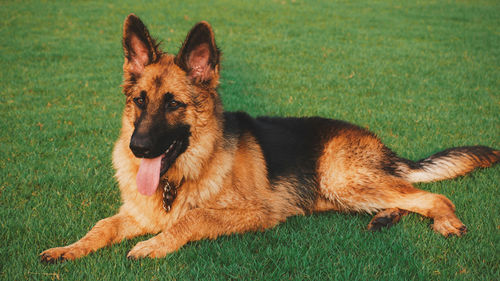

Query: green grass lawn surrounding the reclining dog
[0,0,500,280]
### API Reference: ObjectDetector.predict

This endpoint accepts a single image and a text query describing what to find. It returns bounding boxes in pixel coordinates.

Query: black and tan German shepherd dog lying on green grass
[40,14,500,262]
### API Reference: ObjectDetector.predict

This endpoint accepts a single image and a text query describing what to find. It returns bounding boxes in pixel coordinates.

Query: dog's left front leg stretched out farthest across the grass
[40,213,144,263]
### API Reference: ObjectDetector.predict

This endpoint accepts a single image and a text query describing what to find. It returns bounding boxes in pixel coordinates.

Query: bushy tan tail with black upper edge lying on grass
[400,146,500,182]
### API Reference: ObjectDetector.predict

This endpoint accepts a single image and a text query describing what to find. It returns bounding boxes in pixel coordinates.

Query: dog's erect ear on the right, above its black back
[175,21,220,83]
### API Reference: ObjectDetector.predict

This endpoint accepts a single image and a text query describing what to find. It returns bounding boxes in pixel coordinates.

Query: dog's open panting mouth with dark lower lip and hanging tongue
[136,140,184,196]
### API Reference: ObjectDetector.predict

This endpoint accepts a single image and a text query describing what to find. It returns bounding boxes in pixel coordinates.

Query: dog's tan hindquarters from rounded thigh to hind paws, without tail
[318,134,466,236]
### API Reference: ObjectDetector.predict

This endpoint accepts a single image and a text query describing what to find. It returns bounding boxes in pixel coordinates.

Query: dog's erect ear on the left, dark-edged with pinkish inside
[122,14,161,77]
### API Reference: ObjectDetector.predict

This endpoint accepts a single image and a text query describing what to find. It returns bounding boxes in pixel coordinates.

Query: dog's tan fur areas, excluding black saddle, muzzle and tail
[41,15,491,262]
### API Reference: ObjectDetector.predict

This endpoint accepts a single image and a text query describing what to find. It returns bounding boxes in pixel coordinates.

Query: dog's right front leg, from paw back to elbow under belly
[127,206,279,259]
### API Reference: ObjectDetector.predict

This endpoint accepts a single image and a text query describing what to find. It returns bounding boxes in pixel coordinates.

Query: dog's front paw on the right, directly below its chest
[127,234,179,259]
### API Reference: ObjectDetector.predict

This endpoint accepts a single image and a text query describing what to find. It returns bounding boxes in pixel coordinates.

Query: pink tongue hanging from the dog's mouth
[136,156,162,196]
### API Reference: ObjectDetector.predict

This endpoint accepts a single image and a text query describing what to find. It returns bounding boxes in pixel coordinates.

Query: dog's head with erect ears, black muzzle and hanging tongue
[119,14,221,195]
